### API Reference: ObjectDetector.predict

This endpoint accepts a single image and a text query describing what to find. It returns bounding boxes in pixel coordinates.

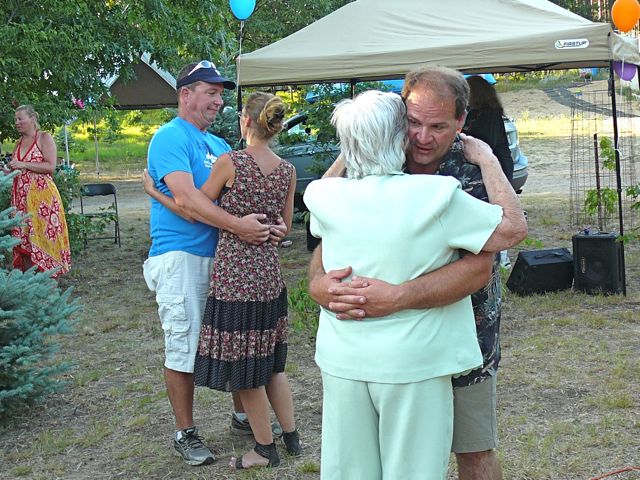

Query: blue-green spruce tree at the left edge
[0,172,80,415]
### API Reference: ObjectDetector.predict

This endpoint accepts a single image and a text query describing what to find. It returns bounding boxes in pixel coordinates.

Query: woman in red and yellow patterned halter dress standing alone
[8,105,71,278]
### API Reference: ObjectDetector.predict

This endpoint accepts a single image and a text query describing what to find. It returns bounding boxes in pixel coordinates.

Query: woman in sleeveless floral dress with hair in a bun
[148,92,302,469]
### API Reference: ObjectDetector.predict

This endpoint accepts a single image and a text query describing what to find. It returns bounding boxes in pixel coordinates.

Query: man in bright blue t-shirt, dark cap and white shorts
[143,60,284,465]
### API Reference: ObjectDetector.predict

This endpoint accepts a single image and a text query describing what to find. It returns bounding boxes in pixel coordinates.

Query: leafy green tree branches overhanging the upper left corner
[0,0,231,140]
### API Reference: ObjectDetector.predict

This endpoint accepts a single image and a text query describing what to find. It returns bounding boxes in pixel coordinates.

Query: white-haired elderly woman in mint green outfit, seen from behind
[304,91,503,480]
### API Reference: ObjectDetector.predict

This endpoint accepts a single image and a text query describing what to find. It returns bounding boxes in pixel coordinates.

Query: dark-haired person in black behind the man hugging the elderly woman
[462,75,513,268]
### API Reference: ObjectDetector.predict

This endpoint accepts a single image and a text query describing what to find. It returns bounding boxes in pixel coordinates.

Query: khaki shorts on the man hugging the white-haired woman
[451,375,498,453]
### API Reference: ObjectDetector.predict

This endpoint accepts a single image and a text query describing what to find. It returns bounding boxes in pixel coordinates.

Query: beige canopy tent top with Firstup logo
[238,0,640,87]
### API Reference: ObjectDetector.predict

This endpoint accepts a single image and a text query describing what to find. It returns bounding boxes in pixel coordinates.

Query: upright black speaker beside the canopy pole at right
[572,233,624,294]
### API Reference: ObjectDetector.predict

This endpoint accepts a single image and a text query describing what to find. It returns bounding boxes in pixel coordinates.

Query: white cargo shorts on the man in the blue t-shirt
[143,252,213,373]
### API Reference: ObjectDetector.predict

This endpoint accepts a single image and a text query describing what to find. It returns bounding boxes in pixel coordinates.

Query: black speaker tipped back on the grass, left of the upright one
[507,248,573,295]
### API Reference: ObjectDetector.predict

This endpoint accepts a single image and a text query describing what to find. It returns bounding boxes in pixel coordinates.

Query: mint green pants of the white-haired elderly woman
[320,372,453,480]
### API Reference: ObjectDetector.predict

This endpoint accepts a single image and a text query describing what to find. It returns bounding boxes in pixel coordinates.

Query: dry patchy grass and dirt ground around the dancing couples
[0,85,640,480]
